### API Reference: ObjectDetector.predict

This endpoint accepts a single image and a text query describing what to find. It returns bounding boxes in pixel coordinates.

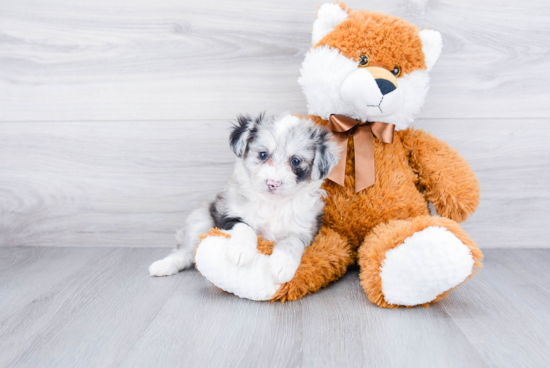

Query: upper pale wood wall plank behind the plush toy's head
[0,0,550,121]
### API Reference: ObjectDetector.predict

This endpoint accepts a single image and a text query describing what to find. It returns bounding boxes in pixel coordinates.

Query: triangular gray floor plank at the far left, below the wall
[0,247,117,367]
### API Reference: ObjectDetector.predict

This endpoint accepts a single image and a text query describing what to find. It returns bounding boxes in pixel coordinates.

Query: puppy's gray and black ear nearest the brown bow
[311,126,340,180]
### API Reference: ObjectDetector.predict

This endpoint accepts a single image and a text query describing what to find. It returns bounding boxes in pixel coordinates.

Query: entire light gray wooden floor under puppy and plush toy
[0,247,550,368]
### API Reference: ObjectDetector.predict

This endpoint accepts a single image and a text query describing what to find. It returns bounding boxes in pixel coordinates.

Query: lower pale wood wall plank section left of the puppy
[0,121,234,247]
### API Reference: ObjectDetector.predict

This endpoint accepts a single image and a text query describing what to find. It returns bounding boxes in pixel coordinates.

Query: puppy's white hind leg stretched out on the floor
[149,205,214,276]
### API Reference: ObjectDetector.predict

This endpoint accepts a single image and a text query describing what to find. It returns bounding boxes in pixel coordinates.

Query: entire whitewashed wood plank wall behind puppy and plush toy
[0,0,550,248]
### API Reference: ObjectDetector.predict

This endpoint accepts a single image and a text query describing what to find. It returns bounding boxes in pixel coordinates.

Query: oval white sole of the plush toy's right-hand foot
[380,226,474,306]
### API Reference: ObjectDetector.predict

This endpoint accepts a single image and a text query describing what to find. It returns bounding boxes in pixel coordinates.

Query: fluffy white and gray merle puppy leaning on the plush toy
[149,114,339,283]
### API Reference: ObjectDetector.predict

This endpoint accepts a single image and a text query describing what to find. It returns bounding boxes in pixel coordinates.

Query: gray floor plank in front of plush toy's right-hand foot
[302,269,487,367]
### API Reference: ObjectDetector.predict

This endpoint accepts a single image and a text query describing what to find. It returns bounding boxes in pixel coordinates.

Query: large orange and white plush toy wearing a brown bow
[195,3,483,308]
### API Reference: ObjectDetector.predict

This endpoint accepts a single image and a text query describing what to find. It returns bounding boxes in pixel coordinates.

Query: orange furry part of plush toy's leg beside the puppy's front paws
[272,227,355,302]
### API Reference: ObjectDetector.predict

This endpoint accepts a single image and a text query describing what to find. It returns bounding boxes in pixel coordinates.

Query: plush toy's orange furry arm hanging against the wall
[401,129,479,222]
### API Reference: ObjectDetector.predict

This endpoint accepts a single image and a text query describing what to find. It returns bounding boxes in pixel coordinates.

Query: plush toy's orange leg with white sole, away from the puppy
[358,216,483,308]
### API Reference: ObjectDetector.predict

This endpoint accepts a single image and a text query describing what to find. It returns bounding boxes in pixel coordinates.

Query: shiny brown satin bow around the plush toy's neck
[328,115,395,193]
